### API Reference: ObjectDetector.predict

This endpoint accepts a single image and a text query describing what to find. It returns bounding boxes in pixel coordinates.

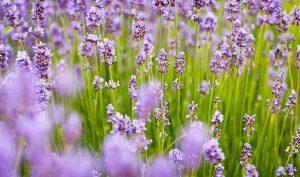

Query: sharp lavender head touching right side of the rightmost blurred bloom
[203,138,225,164]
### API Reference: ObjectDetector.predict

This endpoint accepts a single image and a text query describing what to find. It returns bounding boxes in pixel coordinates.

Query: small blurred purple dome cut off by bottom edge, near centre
[146,157,178,177]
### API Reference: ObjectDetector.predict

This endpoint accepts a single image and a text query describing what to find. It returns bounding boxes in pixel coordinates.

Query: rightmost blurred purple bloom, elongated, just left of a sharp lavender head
[180,121,210,168]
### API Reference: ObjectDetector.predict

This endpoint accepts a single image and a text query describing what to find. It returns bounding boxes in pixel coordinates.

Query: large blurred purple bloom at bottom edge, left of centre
[103,135,141,177]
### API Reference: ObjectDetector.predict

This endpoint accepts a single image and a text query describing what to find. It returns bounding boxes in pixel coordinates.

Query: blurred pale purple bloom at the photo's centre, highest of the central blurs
[134,81,163,121]
